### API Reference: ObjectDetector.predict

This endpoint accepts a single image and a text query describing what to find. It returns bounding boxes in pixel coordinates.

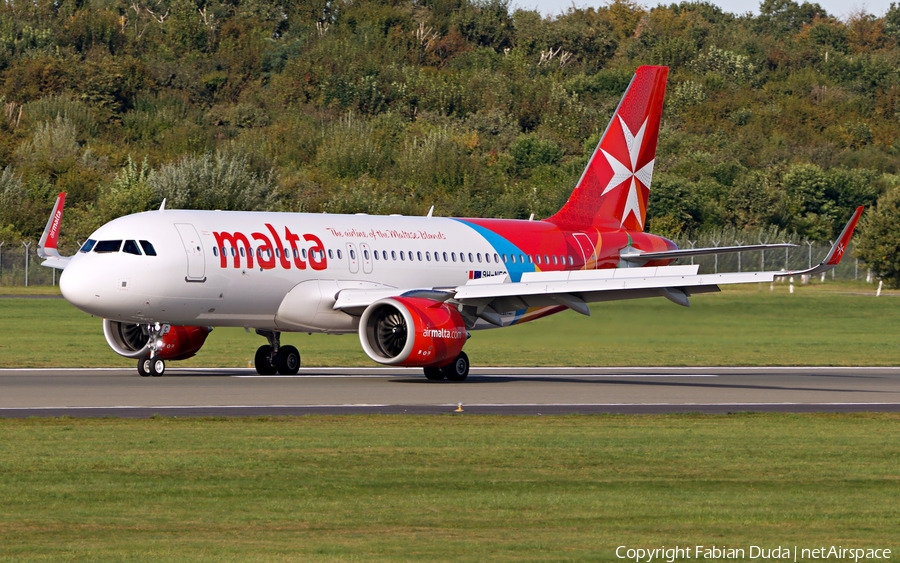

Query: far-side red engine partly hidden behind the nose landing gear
[103,319,212,360]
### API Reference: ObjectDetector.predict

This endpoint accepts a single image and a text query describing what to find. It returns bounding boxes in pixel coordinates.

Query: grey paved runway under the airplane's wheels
[0,367,900,417]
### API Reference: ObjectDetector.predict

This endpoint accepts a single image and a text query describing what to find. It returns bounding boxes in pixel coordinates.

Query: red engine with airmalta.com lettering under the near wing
[359,297,466,367]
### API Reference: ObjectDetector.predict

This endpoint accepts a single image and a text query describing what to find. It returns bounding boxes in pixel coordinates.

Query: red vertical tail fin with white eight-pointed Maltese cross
[547,66,669,231]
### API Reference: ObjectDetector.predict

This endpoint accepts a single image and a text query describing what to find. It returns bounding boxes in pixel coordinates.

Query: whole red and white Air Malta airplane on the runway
[38,66,863,381]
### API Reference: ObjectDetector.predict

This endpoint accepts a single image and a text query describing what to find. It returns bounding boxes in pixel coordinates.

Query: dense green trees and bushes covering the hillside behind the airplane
[0,0,900,264]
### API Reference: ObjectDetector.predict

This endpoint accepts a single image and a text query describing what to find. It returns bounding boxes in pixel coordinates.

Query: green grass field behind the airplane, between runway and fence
[0,283,900,367]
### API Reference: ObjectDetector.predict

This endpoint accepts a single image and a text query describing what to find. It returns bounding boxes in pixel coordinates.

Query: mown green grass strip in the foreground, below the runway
[0,414,900,562]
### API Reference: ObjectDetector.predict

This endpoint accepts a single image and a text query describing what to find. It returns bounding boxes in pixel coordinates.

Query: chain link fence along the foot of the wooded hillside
[0,235,872,286]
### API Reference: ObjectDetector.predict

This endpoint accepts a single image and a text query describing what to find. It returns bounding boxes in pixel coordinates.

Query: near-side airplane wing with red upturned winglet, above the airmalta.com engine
[334,207,863,325]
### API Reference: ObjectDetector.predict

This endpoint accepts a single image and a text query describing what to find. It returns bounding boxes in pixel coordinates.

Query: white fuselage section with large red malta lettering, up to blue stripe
[60,210,534,332]
